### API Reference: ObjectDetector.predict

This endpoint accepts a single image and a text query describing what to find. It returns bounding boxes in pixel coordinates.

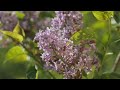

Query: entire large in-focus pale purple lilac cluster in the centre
[35,11,98,79]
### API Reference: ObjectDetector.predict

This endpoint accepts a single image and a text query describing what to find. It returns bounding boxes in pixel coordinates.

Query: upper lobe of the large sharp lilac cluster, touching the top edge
[51,11,83,38]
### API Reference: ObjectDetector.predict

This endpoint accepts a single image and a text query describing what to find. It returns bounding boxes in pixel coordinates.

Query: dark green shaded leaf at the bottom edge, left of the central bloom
[26,66,37,79]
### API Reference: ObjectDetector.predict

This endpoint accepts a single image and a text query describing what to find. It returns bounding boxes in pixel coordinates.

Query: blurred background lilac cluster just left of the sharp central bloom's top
[21,11,51,31]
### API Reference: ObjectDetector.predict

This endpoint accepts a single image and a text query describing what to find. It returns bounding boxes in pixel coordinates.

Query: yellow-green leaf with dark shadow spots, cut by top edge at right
[92,11,114,21]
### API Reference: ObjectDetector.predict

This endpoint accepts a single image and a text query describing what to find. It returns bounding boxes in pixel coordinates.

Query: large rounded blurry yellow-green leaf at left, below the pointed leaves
[6,46,29,63]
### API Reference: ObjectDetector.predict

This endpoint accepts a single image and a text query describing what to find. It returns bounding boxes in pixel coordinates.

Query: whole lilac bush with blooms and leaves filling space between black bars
[0,11,120,79]
